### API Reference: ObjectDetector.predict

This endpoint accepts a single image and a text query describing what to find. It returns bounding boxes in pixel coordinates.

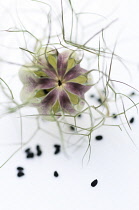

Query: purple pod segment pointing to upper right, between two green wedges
[64,64,87,81]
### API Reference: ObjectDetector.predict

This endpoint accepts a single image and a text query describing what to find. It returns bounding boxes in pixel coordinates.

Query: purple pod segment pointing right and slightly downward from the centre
[65,82,92,97]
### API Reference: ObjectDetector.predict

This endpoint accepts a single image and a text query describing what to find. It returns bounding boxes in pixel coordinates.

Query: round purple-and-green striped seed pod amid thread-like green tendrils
[19,48,92,119]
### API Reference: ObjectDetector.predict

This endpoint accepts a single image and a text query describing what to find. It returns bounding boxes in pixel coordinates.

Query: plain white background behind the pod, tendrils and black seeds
[0,0,139,210]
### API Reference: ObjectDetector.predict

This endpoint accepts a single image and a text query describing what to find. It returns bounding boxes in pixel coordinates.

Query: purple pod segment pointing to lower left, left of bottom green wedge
[38,88,59,114]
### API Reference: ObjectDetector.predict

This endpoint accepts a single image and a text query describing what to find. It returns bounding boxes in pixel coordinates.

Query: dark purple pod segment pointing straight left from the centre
[37,78,56,89]
